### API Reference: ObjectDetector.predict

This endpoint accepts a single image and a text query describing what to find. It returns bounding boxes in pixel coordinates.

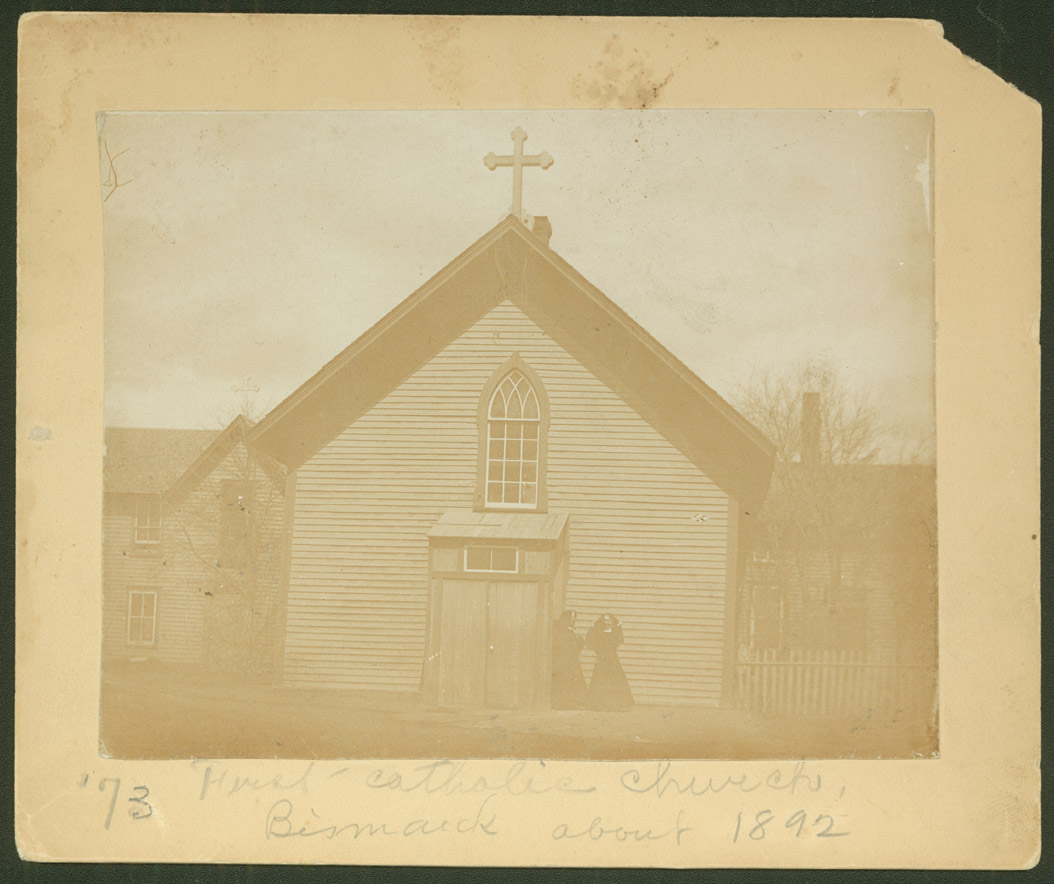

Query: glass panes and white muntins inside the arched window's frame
[484,369,542,509]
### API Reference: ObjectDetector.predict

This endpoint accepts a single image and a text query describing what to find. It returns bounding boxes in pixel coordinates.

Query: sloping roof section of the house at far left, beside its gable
[102,427,219,494]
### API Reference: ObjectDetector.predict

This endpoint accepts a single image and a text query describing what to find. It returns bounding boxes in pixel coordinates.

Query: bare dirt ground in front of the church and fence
[100,667,935,760]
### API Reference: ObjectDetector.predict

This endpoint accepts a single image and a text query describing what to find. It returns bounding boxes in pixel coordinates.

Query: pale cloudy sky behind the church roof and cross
[99,111,934,453]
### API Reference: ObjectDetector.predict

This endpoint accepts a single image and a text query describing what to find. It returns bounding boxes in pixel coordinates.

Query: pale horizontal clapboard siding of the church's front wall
[285,301,729,703]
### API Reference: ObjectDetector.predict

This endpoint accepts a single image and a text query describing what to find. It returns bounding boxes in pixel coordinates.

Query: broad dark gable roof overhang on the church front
[251,215,774,506]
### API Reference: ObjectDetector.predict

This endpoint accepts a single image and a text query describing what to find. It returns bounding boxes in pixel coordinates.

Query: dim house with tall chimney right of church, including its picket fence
[737,393,937,727]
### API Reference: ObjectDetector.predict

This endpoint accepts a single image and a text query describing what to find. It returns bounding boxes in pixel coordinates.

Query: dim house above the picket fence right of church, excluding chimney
[740,464,937,663]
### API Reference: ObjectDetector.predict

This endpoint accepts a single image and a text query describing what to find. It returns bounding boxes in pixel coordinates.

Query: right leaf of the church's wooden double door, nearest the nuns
[486,581,543,709]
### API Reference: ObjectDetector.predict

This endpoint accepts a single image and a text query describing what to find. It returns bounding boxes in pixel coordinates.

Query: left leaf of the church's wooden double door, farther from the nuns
[438,579,487,706]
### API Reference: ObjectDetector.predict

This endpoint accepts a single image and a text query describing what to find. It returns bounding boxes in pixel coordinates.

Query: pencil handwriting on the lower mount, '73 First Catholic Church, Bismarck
[79,760,851,847]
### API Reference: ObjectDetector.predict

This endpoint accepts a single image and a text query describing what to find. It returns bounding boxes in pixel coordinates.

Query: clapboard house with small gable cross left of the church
[102,417,284,674]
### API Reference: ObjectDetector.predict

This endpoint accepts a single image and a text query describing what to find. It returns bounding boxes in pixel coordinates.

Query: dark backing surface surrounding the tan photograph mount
[0,0,1054,884]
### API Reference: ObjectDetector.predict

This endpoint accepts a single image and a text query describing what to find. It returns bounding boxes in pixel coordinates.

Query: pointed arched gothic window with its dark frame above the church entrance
[480,356,548,510]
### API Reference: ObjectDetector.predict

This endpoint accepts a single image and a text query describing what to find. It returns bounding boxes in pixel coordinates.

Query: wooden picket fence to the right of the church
[736,648,925,719]
